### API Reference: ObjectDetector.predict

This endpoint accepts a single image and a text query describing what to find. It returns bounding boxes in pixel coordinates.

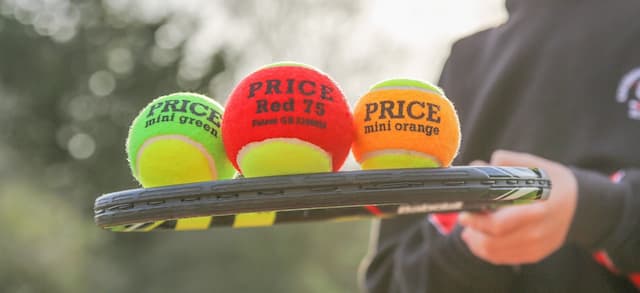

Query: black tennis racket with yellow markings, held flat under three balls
[94,166,551,232]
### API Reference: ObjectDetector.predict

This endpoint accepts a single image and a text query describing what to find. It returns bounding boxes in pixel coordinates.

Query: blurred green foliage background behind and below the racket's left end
[0,0,369,293]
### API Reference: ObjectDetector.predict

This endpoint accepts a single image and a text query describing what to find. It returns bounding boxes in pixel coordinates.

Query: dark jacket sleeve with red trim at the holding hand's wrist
[567,168,640,272]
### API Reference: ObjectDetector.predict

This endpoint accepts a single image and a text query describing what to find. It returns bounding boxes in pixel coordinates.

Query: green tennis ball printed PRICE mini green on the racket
[126,93,235,187]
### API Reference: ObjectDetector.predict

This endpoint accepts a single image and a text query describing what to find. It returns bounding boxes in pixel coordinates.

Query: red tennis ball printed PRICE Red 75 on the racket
[222,62,354,177]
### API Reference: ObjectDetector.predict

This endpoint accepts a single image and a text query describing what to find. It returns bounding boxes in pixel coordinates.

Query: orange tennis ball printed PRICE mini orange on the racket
[353,79,460,170]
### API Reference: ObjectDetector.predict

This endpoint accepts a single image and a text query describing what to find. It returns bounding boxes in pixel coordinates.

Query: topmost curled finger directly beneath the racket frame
[458,203,545,236]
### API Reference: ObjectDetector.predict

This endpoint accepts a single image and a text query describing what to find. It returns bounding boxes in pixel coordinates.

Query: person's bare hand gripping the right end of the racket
[459,150,578,265]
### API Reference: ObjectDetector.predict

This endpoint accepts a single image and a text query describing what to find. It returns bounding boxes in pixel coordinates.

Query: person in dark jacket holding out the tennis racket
[362,0,640,292]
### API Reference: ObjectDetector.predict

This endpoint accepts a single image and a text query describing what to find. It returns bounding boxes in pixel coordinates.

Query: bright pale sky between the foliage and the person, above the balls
[183,0,506,104]
